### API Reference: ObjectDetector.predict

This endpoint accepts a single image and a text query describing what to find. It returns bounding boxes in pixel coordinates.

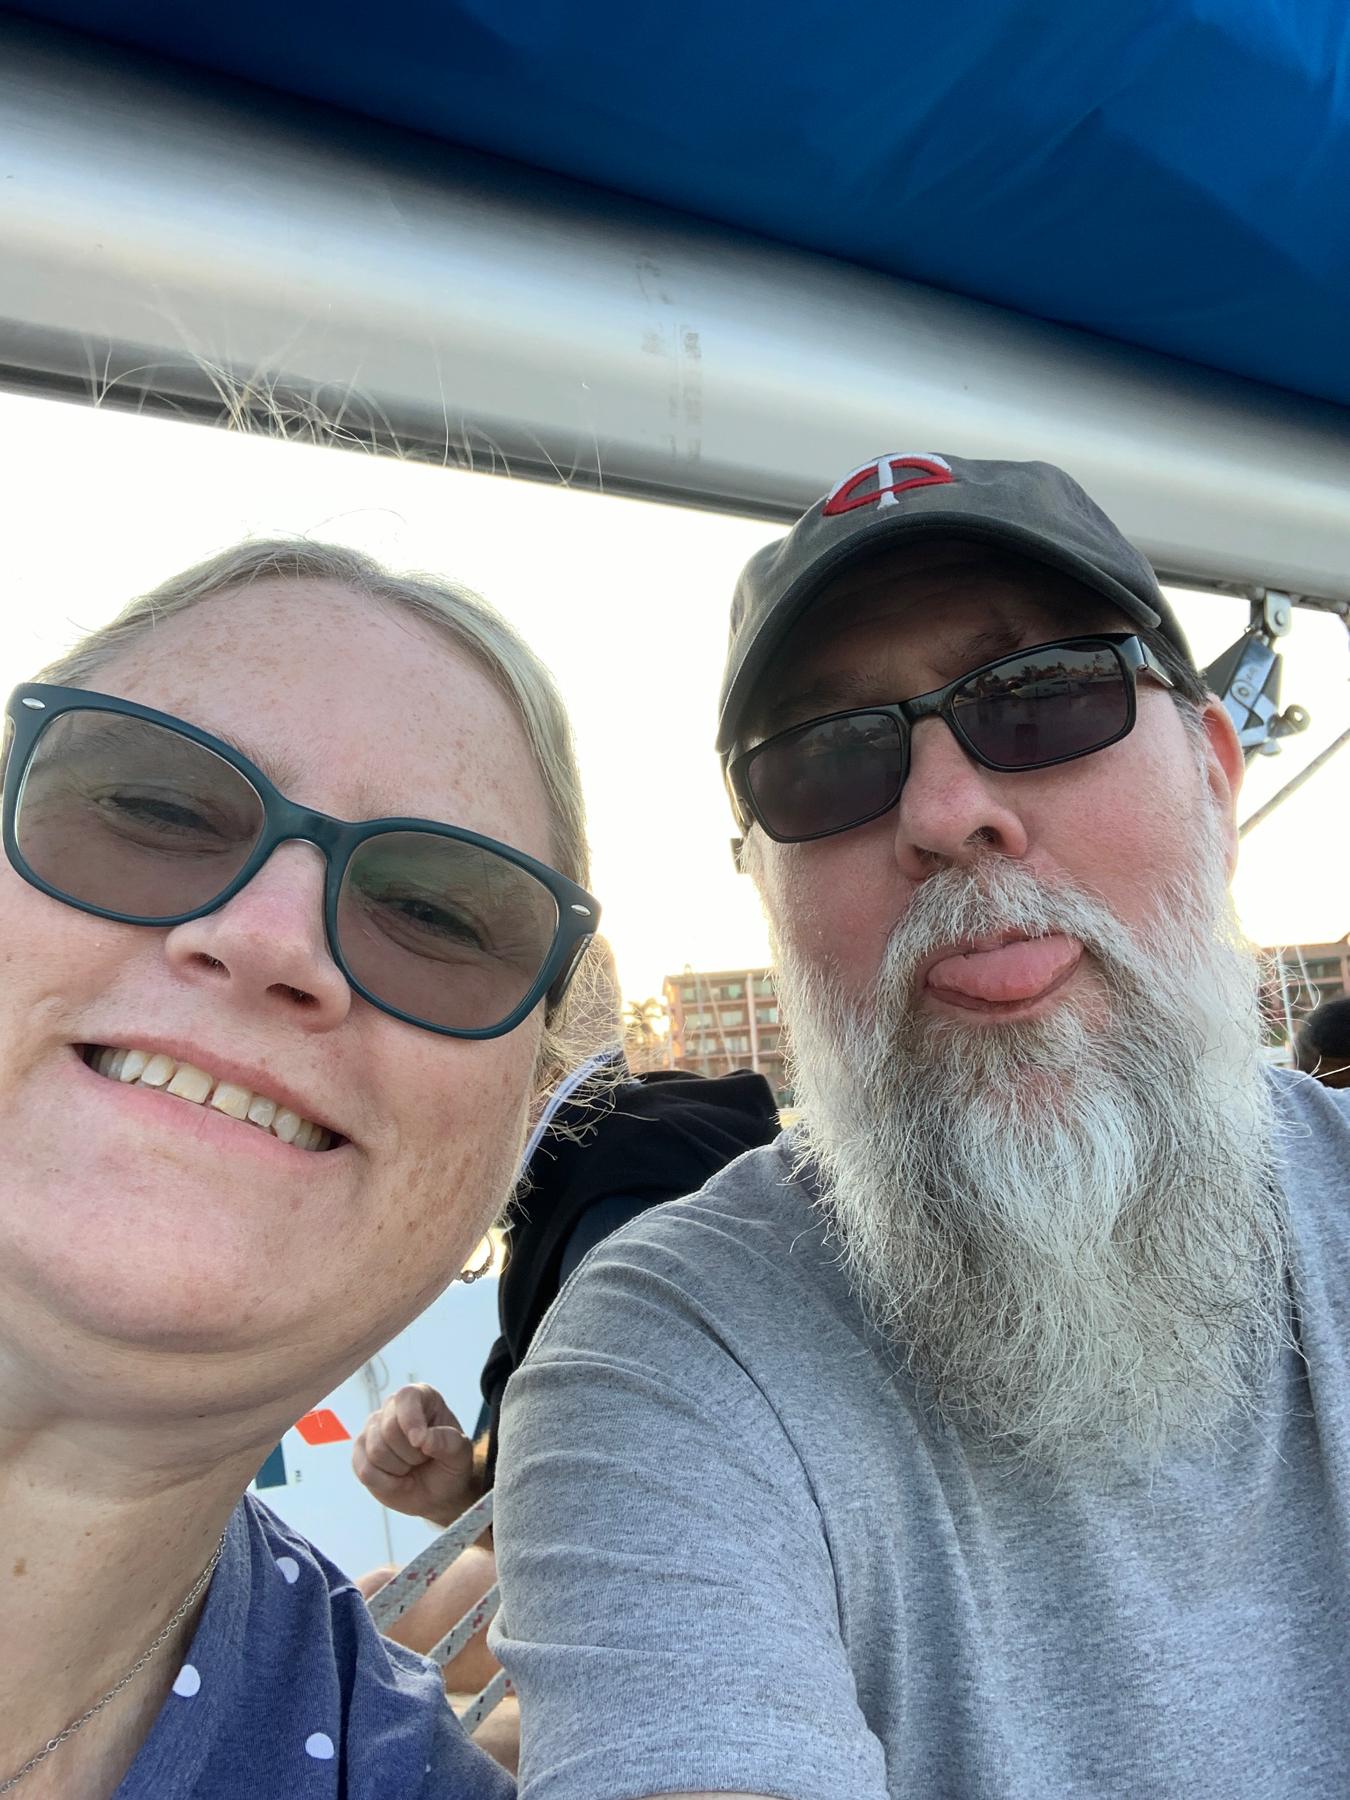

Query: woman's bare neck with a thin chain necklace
[0,1411,266,1800]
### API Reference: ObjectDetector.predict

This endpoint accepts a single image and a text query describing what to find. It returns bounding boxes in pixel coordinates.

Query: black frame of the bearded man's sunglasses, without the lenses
[727,632,1175,844]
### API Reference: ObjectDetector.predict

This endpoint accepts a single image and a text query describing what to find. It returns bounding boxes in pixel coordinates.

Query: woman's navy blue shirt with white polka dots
[117,1494,515,1800]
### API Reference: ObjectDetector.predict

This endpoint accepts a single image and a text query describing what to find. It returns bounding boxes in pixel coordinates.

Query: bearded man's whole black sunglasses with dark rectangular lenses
[727,632,1174,844]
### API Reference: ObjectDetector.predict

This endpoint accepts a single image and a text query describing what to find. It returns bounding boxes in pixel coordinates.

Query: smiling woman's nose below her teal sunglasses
[166,844,351,1031]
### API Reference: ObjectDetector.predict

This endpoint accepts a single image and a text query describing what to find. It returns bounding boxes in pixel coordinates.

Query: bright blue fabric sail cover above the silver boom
[10,0,1350,403]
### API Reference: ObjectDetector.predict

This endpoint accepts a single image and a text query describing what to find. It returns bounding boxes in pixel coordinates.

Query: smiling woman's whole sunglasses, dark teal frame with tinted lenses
[4,684,599,1037]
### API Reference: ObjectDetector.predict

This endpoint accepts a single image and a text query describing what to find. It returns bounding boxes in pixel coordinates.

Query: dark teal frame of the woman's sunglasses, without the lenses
[4,682,599,1039]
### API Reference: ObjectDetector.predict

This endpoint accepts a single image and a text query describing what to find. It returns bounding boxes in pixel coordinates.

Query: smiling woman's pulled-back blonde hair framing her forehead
[38,538,594,1084]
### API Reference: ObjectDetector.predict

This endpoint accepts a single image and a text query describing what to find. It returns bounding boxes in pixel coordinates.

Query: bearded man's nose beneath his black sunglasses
[895,718,1028,880]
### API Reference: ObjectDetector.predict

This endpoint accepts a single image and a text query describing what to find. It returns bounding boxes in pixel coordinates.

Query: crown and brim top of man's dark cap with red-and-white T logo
[716,452,1195,758]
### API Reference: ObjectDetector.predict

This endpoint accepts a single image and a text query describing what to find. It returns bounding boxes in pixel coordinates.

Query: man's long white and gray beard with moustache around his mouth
[778,832,1287,1474]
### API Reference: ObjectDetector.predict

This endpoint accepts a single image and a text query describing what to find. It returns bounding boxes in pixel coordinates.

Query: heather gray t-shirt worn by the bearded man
[497,1076,1350,1800]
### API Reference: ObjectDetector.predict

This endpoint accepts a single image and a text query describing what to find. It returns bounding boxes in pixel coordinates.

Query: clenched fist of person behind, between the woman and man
[351,1381,479,1526]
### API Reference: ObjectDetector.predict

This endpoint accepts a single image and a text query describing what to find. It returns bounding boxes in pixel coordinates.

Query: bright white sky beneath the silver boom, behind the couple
[0,394,1350,997]
